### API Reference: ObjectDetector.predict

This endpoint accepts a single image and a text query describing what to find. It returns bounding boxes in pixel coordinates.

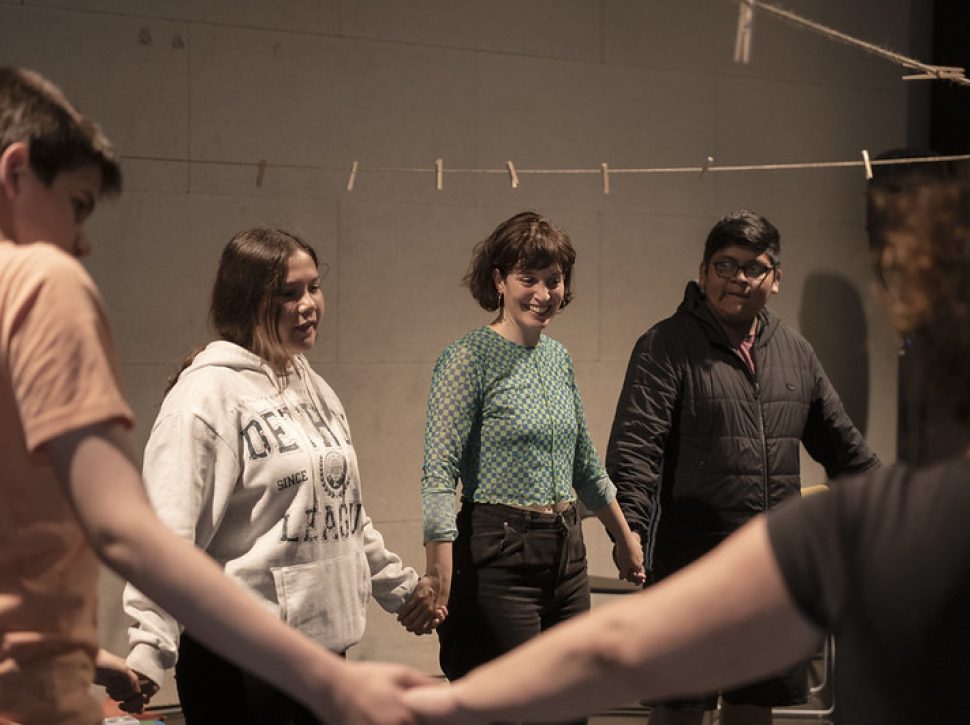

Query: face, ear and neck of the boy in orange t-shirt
[0,144,101,257]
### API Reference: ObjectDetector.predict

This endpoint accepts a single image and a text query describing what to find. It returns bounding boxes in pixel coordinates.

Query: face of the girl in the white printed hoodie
[276,250,324,355]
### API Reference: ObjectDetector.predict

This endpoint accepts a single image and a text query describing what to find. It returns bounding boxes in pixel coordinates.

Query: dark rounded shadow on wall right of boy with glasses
[798,273,869,435]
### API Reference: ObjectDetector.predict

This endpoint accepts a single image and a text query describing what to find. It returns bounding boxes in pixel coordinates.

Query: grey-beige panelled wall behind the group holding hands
[0,0,919,701]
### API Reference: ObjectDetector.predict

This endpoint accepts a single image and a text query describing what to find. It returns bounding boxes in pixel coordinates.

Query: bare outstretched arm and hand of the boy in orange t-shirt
[44,423,421,723]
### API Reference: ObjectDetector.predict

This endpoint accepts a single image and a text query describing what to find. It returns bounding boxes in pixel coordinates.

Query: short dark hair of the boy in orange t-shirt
[0,66,121,195]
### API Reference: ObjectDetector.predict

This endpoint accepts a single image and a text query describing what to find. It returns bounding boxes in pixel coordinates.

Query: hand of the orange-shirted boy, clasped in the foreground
[330,662,435,725]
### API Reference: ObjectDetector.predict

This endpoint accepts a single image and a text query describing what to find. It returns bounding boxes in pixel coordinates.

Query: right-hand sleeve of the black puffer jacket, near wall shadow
[802,352,879,480]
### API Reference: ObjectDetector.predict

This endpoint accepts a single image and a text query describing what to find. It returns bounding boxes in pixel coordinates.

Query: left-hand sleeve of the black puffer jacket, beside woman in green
[606,327,681,570]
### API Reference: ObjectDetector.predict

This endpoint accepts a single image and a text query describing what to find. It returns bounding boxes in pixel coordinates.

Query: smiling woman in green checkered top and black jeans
[421,212,644,680]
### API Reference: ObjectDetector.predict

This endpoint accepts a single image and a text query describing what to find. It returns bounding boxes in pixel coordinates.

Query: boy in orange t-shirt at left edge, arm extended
[0,67,423,725]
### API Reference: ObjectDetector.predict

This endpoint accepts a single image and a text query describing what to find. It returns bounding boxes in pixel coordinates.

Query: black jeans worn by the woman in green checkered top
[438,501,589,720]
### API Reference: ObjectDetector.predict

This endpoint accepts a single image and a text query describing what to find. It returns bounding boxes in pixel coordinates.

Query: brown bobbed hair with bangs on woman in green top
[464,211,576,312]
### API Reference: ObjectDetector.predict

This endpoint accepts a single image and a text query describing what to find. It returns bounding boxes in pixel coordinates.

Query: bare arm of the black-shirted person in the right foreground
[405,517,822,725]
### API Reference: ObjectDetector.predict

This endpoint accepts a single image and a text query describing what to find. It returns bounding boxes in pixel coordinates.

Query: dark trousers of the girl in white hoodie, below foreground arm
[175,633,319,725]
